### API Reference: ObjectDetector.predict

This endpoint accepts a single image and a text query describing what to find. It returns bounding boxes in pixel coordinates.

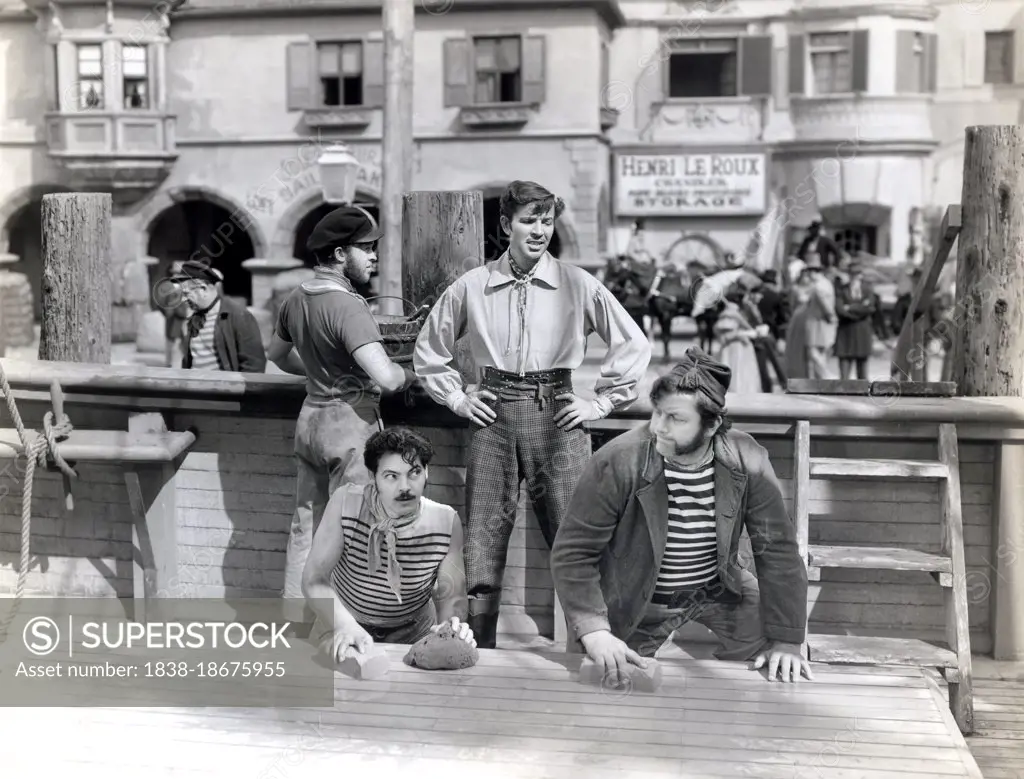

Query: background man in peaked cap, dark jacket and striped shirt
[171,260,266,374]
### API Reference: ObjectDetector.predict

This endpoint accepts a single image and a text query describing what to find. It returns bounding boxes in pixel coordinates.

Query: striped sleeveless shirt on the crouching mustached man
[331,484,460,627]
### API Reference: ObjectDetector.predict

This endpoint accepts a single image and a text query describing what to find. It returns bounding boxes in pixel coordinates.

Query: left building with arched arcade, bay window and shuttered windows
[0,0,623,331]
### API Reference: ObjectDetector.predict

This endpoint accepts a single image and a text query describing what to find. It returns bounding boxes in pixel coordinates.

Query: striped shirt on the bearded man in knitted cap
[652,459,718,605]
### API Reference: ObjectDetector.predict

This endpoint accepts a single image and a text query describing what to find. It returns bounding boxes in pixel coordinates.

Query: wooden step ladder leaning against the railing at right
[794,382,974,734]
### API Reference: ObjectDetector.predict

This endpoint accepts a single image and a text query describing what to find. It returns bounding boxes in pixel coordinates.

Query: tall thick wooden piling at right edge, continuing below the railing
[950,126,1024,660]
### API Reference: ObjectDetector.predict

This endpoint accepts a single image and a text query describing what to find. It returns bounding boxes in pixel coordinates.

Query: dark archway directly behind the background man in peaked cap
[146,200,256,304]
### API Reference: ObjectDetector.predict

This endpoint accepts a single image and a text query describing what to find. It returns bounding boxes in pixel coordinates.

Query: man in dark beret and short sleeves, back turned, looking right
[269,206,416,622]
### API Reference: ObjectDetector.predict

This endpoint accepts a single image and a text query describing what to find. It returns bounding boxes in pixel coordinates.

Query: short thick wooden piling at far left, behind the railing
[39,192,113,364]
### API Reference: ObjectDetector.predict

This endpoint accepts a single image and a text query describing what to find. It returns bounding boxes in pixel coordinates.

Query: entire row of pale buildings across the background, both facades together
[0,0,1024,331]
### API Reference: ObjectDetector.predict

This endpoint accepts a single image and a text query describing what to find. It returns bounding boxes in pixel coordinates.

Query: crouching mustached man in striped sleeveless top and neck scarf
[302,428,476,662]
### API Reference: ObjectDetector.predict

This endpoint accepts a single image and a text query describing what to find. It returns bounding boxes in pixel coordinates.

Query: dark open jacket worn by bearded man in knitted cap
[551,425,807,644]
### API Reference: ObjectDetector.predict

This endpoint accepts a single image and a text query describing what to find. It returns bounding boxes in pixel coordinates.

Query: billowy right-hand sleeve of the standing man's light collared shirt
[587,285,651,408]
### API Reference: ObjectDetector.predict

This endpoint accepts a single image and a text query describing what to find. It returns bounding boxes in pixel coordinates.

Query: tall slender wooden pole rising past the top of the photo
[379,0,416,314]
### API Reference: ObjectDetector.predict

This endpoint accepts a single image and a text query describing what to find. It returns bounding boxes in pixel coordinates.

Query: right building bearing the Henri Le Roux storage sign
[604,0,1024,266]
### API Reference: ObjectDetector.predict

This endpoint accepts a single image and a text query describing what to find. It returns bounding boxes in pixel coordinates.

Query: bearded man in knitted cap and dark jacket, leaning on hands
[551,348,812,682]
